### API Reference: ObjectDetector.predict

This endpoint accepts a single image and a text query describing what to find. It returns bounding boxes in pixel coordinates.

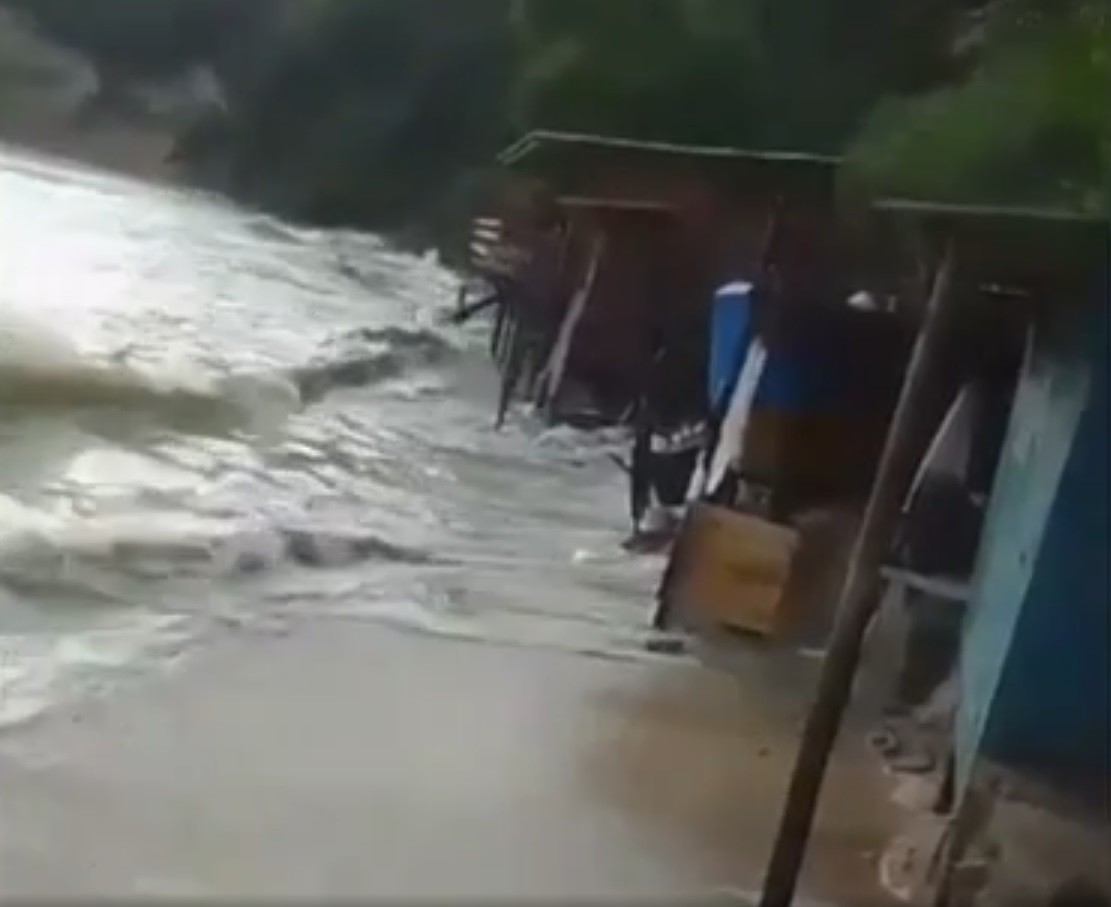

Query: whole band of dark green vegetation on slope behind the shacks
[0,0,1111,247]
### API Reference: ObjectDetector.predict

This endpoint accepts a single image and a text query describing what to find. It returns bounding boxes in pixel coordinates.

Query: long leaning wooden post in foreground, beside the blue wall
[760,249,954,907]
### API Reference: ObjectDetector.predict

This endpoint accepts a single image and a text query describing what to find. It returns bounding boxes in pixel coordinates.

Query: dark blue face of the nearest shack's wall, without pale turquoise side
[983,300,1111,781]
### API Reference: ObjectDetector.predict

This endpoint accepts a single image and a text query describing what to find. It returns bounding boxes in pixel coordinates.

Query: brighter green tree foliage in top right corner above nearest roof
[851,0,1111,212]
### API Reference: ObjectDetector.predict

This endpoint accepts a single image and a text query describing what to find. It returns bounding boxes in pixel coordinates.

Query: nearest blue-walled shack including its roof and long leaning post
[761,201,1111,907]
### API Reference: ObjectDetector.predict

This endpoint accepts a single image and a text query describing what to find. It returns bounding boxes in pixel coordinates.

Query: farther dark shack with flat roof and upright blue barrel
[486,132,907,555]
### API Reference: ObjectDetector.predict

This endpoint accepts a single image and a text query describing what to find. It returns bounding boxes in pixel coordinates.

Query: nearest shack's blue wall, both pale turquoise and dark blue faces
[957,297,1109,787]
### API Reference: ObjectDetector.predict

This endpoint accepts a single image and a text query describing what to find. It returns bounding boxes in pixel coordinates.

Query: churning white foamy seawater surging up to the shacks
[0,152,661,727]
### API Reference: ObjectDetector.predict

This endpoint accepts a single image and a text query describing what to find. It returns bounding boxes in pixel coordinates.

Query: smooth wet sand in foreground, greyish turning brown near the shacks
[0,621,894,905]
